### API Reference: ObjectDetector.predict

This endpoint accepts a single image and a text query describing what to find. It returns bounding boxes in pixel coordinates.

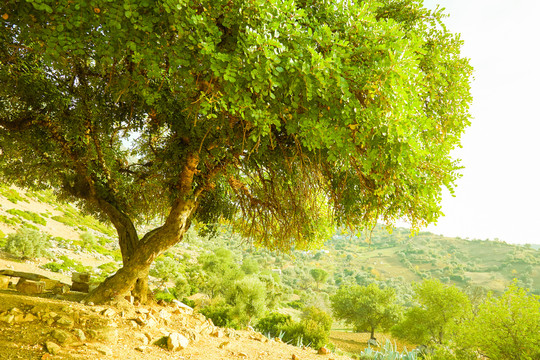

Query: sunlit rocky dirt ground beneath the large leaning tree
[0,289,354,360]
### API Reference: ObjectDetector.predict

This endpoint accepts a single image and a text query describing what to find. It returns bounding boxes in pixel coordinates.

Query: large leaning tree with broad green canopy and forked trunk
[0,0,471,301]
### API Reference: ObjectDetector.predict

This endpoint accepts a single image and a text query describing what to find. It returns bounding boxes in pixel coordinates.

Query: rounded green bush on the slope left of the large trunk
[4,228,50,258]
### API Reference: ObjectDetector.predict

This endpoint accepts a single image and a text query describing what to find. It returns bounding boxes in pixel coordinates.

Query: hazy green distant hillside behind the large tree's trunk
[0,185,540,298]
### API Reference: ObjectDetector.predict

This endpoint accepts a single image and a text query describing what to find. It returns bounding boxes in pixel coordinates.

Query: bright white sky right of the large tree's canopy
[424,0,540,244]
